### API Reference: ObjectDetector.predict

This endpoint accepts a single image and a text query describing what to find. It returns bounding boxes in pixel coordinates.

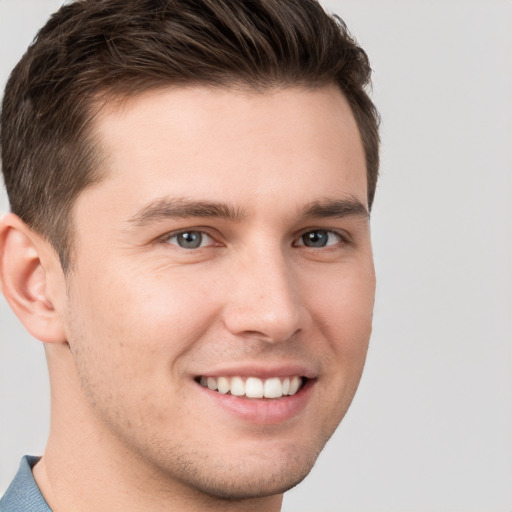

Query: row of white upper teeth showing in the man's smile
[199,376,302,398]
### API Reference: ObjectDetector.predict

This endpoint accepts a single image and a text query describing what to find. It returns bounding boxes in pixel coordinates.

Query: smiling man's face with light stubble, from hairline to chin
[64,86,375,498]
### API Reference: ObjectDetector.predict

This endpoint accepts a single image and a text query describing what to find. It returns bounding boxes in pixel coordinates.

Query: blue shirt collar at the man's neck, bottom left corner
[0,455,52,512]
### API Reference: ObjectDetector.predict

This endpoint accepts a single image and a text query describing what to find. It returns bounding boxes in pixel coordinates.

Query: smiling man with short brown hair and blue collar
[0,0,378,512]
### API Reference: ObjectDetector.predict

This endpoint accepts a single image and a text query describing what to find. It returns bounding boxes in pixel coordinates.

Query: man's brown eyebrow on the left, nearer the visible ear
[128,197,246,226]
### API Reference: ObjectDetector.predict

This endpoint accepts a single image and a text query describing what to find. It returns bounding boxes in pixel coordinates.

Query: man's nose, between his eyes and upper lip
[224,248,309,343]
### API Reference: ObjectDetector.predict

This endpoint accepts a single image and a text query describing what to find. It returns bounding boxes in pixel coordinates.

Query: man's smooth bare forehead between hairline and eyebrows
[79,85,366,218]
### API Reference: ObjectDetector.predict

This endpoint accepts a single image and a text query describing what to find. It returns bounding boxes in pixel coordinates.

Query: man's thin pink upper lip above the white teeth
[195,363,318,379]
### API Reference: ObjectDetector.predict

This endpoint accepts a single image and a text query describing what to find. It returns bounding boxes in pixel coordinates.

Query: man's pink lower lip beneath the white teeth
[197,380,315,425]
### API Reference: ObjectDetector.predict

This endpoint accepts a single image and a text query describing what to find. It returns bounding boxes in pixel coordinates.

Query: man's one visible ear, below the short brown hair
[0,213,66,343]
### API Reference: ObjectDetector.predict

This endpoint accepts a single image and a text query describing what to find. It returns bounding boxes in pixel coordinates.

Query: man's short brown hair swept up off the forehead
[0,0,379,271]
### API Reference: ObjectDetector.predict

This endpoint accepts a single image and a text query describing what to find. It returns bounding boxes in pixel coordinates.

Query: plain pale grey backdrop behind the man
[0,0,512,512]
